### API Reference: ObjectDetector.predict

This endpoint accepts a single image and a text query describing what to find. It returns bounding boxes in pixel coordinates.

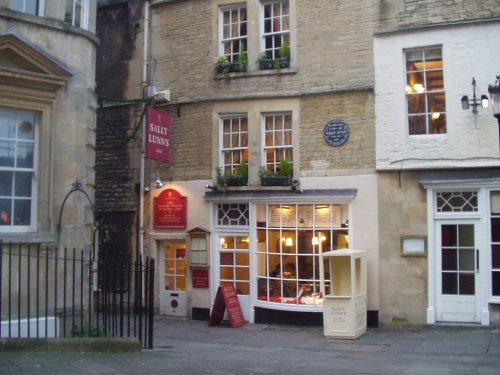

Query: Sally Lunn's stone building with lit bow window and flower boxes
[98,0,378,325]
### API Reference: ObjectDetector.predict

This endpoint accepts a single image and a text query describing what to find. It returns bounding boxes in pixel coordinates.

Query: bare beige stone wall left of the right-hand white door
[378,172,428,326]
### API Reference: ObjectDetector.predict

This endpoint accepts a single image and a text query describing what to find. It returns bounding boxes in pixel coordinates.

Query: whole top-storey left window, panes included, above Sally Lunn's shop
[219,5,247,63]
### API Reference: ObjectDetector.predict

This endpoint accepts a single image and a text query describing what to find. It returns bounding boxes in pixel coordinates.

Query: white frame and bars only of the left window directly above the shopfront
[219,113,249,174]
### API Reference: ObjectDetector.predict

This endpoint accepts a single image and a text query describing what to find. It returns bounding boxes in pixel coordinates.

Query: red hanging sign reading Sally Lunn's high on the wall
[146,107,170,163]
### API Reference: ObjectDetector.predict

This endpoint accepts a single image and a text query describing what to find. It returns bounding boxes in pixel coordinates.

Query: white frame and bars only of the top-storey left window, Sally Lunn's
[219,4,248,63]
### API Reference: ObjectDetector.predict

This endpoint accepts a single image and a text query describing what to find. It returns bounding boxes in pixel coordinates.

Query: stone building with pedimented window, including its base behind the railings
[0,0,98,326]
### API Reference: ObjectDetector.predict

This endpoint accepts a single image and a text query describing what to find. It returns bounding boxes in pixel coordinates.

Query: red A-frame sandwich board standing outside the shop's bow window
[208,284,246,328]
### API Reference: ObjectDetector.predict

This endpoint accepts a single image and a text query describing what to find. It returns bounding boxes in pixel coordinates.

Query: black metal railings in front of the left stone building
[0,240,154,349]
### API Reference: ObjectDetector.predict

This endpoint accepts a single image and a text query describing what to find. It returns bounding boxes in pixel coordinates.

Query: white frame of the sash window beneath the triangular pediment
[0,107,41,233]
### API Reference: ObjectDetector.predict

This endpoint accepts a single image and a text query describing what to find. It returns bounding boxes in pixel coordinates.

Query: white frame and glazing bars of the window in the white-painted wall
[403,45,448,137]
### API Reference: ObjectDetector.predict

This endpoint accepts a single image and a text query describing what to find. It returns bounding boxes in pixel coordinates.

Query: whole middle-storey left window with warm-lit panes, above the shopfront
[220,115,248,175]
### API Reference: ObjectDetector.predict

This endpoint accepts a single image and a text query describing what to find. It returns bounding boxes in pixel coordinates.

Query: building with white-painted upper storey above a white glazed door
[374,1,500,325]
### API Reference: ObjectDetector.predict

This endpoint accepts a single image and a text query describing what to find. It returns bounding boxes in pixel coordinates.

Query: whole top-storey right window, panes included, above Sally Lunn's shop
[260,0,290,60]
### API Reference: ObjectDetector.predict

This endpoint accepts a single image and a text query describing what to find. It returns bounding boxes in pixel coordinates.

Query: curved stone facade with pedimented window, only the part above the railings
[0,0,98,253]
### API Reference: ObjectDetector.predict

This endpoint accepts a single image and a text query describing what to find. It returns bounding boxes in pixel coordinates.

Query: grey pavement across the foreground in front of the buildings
[0,316,500,375]
